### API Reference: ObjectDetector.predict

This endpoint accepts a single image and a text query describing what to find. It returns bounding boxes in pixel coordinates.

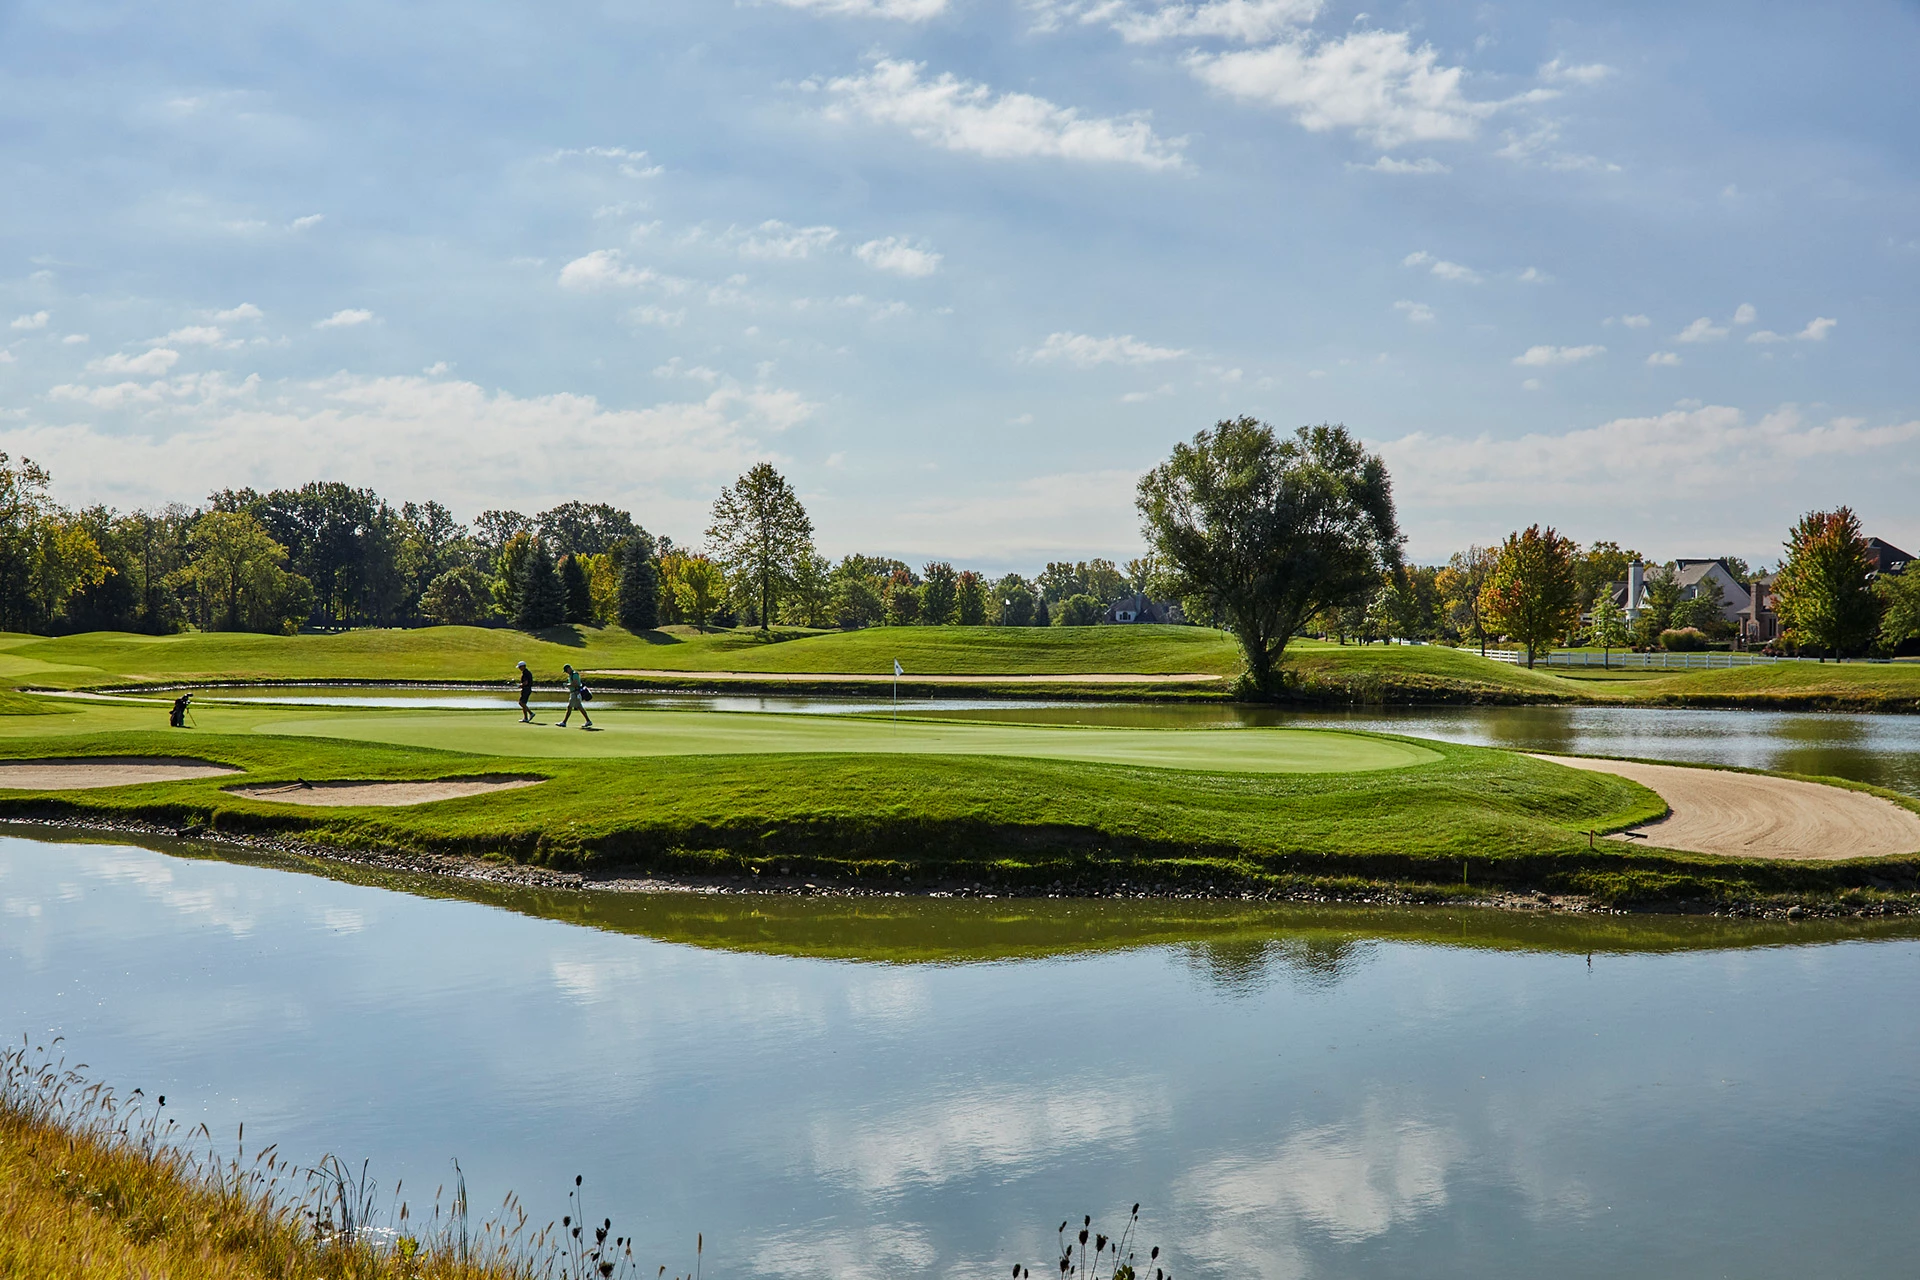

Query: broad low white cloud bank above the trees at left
[0,370,816,528]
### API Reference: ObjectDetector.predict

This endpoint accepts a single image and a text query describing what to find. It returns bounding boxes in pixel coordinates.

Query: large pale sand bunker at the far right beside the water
[1534,756,1920,860]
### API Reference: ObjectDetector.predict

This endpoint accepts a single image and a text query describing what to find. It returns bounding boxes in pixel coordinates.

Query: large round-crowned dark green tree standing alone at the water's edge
[1135,416,1400,695]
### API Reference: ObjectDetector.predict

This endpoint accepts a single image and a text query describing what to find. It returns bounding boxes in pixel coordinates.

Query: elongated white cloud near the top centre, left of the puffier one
[826,58,1185,171]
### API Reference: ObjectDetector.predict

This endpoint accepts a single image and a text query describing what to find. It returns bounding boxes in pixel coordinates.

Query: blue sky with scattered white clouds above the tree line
[0,0,1920,572]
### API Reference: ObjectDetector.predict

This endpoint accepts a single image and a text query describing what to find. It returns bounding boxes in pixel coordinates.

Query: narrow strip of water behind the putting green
[149,685,1920,796]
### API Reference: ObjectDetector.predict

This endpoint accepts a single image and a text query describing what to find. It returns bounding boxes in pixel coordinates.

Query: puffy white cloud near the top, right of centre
[1187,31,1498,148]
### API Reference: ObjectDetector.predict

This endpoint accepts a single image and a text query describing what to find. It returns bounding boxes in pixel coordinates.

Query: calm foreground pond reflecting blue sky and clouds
[0,837,1920,1280]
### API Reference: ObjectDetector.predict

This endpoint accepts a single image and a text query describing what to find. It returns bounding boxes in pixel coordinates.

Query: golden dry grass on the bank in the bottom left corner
[0,1042,678,1280]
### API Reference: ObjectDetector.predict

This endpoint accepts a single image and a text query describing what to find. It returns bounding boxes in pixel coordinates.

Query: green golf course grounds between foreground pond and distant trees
[0,628,1920,904]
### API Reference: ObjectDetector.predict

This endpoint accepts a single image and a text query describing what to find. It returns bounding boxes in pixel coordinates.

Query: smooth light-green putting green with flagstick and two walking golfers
[252,710,1440,773]
